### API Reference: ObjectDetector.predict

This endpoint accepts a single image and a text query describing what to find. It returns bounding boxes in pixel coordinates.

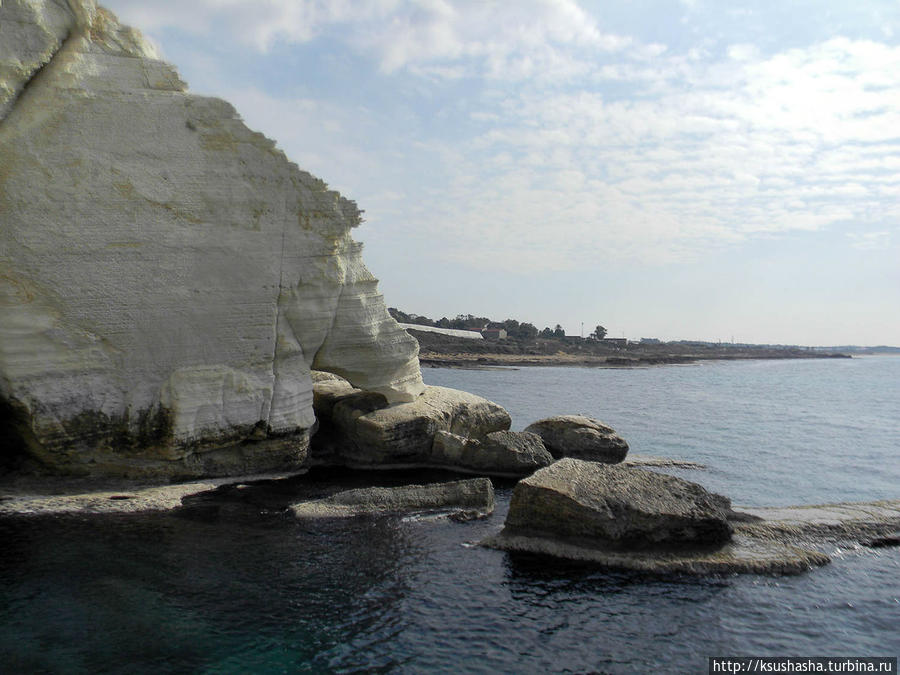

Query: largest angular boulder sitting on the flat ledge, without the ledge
[496,459,733,548]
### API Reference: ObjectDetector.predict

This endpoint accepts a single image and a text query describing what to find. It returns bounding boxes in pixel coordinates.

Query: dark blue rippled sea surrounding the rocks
[0,356,900,673]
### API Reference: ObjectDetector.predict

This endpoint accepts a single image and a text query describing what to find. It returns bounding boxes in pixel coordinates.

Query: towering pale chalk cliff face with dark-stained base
[0,0,423,476]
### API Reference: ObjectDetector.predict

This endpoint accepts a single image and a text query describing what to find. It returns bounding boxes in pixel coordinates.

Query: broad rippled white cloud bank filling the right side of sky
[370,39,900,269]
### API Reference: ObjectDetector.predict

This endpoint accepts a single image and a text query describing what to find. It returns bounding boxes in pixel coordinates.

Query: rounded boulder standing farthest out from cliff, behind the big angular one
[525,415,628,464]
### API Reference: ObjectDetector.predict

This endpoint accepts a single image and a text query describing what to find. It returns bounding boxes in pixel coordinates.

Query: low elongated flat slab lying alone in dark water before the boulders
[291,478,494,519]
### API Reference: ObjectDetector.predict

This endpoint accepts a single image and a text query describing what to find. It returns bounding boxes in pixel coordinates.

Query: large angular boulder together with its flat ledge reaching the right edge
[481,459,900,574]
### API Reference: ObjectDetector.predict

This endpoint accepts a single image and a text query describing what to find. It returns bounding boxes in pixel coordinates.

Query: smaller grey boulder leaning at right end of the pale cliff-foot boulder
[431,431,553,478]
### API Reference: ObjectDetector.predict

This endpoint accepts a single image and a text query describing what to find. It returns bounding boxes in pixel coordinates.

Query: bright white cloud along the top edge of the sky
[109,0,632,79]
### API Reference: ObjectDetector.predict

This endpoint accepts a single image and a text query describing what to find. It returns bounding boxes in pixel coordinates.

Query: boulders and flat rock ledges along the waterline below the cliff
[0,372,900,574]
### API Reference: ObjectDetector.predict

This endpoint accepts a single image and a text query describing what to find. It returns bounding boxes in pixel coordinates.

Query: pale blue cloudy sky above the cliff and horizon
[104,0,900,345]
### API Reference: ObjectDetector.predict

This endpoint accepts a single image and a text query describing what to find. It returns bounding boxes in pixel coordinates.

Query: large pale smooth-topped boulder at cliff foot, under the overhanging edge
[311,375,512,476]
